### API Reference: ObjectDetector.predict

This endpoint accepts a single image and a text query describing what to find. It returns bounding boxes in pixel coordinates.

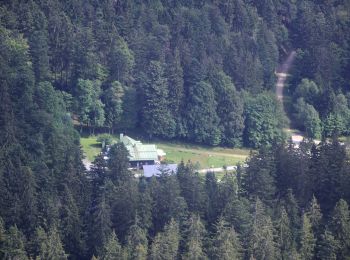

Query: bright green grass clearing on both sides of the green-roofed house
[80,136,249,169]
